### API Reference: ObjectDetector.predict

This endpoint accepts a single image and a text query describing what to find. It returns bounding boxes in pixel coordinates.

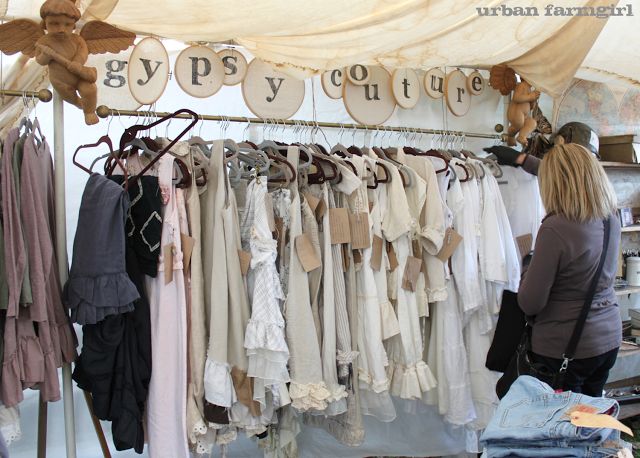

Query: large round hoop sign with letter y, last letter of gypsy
[242,59,305,119]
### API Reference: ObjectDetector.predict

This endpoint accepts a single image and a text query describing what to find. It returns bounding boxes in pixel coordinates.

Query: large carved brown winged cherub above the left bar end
[0,0,136,124]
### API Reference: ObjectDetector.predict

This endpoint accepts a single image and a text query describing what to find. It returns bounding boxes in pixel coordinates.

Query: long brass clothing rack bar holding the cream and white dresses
[96,105,502,140]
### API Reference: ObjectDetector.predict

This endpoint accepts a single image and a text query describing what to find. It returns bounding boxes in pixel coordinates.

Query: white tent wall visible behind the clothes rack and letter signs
[3,45,510,458]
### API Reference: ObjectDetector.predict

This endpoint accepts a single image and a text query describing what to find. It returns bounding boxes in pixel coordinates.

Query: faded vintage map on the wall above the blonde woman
[554,80,640,136]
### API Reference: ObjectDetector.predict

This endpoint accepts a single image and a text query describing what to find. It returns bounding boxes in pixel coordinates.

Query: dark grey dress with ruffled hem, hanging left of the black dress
[64,173,140,325]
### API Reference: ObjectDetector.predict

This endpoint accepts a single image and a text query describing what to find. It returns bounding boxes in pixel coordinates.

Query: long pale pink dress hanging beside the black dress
[146,154,189,458]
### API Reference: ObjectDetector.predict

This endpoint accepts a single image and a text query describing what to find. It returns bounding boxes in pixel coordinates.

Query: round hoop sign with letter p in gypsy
[174,46,224,99]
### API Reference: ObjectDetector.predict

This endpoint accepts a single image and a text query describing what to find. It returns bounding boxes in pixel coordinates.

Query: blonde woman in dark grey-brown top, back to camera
[518,143,622,396]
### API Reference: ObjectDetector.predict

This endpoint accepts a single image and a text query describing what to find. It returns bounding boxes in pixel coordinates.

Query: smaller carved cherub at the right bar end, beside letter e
[491,65,540,147]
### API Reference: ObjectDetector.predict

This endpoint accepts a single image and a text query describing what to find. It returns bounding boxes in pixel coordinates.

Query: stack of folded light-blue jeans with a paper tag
[480,375,632,458]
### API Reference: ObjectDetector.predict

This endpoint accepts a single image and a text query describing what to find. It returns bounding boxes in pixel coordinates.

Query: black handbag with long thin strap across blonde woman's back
[496,219,611,399]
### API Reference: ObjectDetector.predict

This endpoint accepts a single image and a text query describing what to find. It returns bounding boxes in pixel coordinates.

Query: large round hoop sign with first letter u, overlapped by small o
[342,67,396,125]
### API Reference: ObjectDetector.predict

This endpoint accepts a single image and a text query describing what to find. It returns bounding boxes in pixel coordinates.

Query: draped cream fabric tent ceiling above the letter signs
[0,0,640,96]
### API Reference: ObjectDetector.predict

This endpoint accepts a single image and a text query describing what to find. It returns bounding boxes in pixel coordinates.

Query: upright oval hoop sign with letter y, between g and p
[128,37,169,105]
